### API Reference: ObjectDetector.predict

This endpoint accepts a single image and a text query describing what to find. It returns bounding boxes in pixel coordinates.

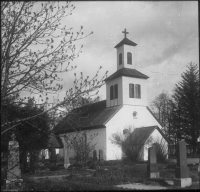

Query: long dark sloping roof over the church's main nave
[53,100,122,134]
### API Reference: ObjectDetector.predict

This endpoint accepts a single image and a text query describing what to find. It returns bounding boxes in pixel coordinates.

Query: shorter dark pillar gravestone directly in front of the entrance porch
[147,146,160,178]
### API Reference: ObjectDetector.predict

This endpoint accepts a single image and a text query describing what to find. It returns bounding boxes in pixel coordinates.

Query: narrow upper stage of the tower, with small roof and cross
[115,29,137,70]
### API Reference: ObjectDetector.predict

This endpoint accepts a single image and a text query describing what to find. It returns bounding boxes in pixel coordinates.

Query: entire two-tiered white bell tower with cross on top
[105,29,149,107]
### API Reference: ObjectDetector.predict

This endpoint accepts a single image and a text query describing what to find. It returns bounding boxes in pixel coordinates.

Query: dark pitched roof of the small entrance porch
[131,126,169,145]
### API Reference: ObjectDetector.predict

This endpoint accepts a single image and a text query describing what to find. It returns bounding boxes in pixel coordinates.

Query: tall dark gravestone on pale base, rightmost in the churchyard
[174,140,192,187]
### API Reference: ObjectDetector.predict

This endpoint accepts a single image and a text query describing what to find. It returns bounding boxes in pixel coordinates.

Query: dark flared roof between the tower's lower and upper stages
[105,68,149,81]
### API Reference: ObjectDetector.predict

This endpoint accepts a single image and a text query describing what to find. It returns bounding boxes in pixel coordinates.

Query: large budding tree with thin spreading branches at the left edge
[1,1,107,134]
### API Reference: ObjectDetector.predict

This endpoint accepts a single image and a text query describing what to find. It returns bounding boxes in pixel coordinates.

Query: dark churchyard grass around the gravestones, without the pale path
[2,162,199,191]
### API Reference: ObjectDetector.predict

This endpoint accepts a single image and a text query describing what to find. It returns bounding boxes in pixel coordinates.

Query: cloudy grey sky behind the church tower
[32,1,199,104]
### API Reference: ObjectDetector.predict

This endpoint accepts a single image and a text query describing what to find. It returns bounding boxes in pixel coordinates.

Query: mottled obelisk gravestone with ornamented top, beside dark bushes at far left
[6,134,22,190]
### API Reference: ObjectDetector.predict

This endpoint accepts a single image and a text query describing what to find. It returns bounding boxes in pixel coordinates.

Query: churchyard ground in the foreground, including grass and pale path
[1,161,200,191]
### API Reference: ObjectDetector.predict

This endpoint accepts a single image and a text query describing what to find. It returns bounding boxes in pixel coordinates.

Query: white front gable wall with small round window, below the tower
[106,105,161,160]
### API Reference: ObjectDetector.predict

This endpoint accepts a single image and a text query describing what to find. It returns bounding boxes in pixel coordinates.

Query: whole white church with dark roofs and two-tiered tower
[54,30,168,168]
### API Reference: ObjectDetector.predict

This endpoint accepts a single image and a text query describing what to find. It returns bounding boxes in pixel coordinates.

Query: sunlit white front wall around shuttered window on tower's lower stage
[122,77,147,106]
